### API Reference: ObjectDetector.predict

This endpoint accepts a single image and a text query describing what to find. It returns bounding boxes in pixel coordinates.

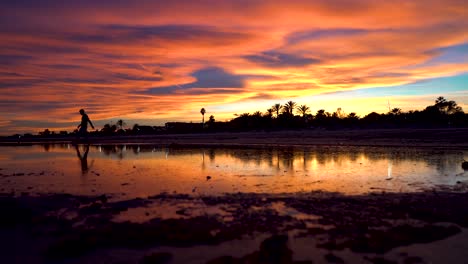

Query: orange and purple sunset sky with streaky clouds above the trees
[0,0,468,135]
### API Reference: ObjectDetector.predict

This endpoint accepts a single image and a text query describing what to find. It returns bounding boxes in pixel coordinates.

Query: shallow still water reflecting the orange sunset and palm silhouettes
[0,145,468,198]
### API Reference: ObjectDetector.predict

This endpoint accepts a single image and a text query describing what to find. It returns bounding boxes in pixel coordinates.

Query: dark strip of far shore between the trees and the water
[0,128,468,149]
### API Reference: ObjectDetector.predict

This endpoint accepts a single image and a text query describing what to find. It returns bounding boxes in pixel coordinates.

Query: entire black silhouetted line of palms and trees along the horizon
[7,96,468,137]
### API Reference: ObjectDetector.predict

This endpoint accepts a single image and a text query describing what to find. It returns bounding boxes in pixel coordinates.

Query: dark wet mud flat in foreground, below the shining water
[0,184,468,263]
